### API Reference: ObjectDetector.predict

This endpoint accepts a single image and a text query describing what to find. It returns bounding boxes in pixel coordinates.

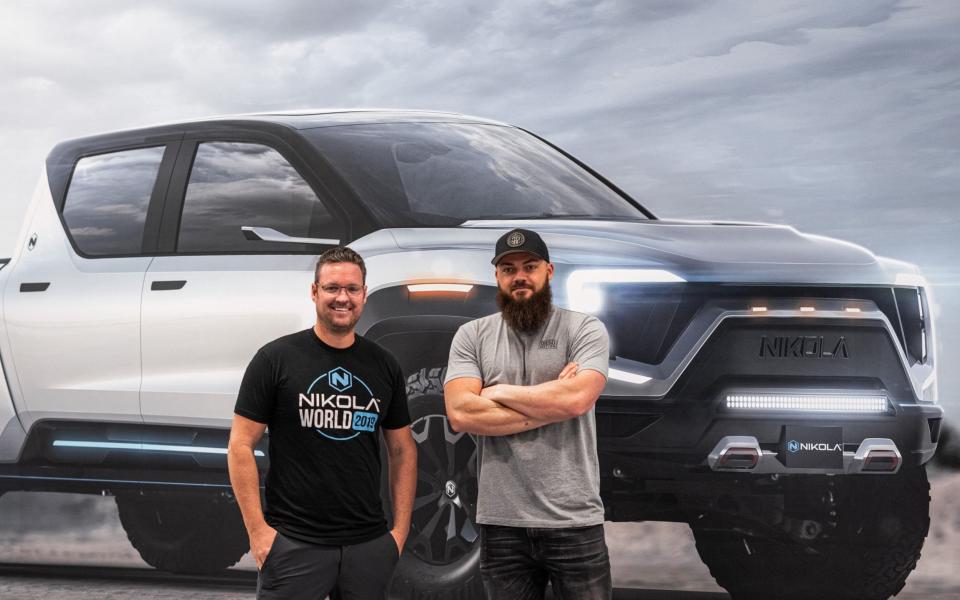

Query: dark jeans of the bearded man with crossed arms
[480,525,613,600]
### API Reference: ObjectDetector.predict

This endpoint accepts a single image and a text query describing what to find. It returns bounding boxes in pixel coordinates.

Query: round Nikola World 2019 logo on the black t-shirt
[297,367,380,441]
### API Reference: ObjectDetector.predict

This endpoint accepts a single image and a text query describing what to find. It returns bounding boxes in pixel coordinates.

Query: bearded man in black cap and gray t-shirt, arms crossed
[444,229,612,600]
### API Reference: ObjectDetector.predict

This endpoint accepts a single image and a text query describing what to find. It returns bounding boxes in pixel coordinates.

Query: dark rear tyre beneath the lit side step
[116,492,250,573]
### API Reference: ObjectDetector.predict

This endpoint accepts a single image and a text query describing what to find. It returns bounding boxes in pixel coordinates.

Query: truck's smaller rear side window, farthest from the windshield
[63,146,164,256]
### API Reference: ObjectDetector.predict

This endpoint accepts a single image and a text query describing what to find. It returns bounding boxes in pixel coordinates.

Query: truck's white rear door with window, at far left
[4,143,179,427]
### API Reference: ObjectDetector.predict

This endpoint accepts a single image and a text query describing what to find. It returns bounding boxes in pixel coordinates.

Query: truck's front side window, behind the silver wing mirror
[177,142,340,253]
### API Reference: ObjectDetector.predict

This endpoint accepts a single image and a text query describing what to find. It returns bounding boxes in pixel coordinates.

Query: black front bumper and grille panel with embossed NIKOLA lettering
[596,318,943,480]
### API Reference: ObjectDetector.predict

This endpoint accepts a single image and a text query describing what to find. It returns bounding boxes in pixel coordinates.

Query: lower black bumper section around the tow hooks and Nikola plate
[597,399,943,480]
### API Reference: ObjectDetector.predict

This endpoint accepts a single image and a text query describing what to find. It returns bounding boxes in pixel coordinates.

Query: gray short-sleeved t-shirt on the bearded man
[444,307,610,527]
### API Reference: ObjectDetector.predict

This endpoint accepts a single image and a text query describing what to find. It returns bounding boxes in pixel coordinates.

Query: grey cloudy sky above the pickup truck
[0,0,960,409]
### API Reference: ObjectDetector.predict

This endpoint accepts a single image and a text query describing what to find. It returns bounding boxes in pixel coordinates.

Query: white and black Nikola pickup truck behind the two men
[0,110,943,599]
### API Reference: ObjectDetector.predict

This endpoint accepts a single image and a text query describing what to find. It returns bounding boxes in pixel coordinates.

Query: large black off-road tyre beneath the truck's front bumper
[691,467,930,600]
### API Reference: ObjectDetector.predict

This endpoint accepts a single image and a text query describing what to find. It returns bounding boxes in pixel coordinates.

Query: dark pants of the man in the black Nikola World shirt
[257,532,400,600]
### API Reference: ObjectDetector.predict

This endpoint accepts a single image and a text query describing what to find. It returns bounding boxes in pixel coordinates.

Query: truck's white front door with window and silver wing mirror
[140,137,346,427]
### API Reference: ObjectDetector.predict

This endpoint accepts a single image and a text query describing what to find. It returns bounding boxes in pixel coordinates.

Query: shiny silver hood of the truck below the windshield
[370,219,919,285]
